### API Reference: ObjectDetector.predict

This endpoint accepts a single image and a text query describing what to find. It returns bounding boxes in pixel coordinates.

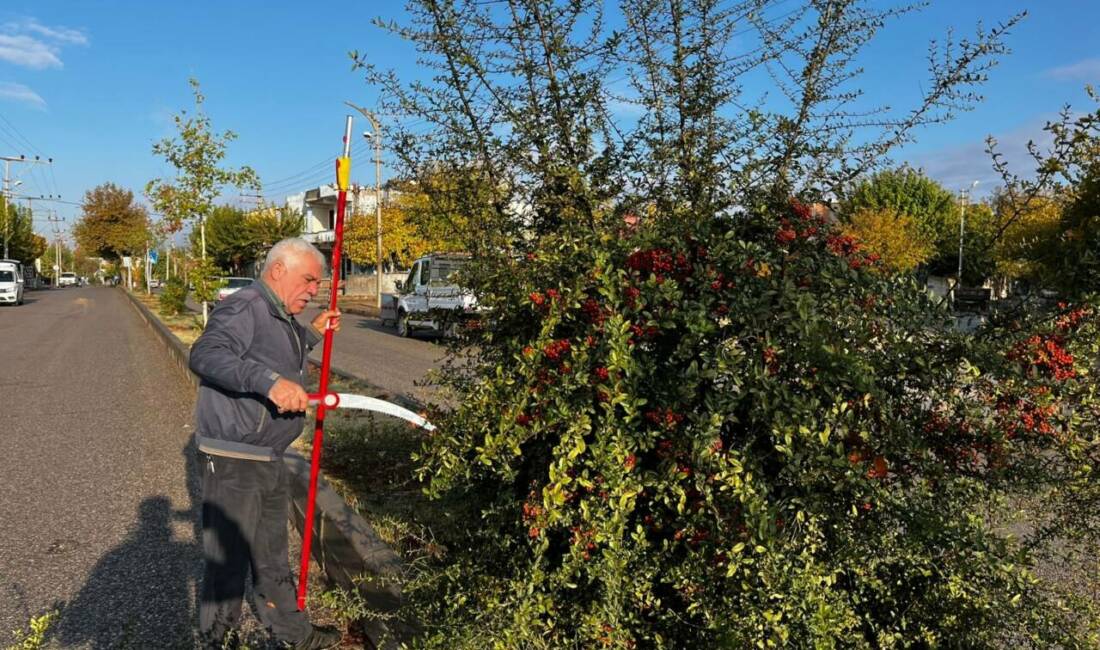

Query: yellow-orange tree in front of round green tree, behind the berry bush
[843,209,934,273]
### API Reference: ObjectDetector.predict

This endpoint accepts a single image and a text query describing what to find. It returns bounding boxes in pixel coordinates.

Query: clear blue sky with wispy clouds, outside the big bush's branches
[0,0,1100,243]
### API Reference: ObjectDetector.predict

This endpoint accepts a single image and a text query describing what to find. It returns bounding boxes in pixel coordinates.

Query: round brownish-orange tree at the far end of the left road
[73,183,151,261]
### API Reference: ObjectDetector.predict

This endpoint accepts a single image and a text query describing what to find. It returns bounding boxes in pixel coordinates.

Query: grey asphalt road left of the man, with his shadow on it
[0,287,200,648]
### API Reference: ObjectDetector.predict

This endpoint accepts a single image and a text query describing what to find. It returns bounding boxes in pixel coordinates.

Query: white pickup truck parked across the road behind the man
[382,253,477,337]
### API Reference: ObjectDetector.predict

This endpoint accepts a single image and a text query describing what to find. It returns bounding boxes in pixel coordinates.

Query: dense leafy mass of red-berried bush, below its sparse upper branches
[396,202,1098,648]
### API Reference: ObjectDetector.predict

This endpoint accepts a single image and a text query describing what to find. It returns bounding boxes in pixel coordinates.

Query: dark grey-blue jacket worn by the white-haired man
[190,280,321,461]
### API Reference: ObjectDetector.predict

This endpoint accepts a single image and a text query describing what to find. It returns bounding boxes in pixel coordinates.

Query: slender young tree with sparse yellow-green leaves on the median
[145,78,260,326]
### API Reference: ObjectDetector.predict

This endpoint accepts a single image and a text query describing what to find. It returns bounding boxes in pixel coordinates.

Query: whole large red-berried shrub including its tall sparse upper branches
[347,0,1098,648]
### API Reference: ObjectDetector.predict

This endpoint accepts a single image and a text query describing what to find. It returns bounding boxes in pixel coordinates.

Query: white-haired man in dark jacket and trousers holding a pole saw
[190,239,340,650]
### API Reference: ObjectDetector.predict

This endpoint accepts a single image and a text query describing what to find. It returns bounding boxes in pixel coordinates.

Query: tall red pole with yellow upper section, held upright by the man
[298,115,351,609]
